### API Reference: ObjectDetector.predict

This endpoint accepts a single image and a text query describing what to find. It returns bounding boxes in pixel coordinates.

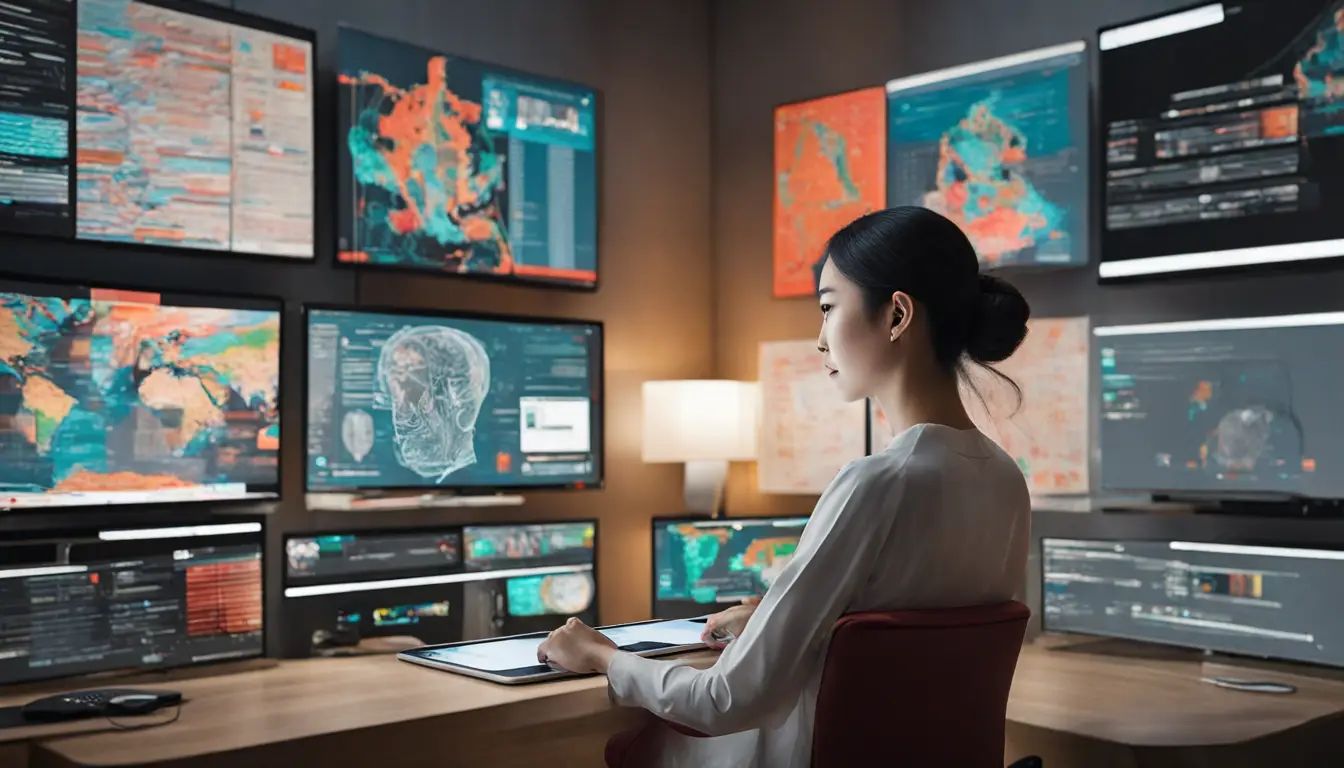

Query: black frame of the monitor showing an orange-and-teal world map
[0,270,288,515]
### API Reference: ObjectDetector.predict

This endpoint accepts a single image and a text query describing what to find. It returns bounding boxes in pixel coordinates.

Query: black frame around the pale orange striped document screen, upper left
[0,0,325,265]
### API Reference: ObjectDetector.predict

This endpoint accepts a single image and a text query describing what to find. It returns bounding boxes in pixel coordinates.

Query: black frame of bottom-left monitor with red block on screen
[0,515,271,693]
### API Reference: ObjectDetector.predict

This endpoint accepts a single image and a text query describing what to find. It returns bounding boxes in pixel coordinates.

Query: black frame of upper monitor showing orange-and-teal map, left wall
[331,22,606,293]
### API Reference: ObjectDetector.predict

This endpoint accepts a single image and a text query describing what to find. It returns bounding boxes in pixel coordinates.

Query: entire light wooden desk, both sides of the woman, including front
[0,639,1344,768]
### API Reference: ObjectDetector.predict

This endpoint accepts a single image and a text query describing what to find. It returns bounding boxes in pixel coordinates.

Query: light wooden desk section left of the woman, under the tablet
[0,651,716,768]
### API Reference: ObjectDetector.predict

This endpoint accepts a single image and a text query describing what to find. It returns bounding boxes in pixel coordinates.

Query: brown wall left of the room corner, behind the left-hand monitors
[0,0,714,652]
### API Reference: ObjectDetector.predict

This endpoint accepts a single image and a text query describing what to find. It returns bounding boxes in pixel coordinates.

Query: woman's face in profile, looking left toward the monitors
[817,258,894,402]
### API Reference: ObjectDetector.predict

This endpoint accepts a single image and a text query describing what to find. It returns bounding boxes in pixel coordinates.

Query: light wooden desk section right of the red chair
[1005,638,1344,768]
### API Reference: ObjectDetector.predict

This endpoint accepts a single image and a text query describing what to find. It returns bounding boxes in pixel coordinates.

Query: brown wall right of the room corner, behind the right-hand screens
[711,0,1344,515]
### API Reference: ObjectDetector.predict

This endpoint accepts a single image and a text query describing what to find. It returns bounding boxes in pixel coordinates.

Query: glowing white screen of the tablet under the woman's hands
[396,617,704,685]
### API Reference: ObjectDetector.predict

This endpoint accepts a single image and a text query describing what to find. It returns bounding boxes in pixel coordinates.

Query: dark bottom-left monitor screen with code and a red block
[0,522,265,683]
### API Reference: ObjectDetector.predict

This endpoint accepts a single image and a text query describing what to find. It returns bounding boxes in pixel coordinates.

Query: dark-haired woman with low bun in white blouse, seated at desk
[538,207,1031,768]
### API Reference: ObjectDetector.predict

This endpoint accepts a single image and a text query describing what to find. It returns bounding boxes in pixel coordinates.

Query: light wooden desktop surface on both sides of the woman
[0,640,1344,765]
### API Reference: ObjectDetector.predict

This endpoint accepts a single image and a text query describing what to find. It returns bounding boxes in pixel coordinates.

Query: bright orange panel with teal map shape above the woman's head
[774,87,887,297]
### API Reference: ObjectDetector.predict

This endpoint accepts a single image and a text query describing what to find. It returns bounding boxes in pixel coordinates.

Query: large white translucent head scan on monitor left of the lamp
[376,325,491,483]
